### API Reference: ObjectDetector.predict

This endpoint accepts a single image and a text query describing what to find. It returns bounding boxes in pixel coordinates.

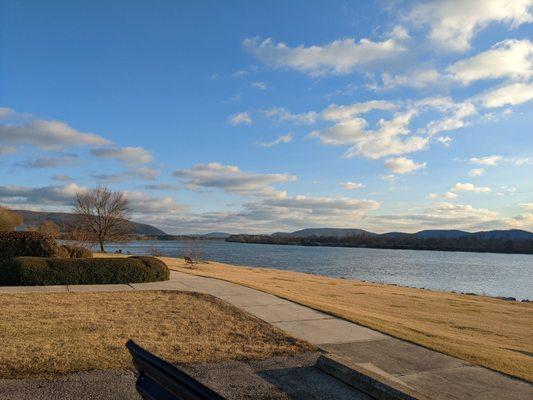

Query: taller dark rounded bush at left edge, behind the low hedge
[0,232,64,261]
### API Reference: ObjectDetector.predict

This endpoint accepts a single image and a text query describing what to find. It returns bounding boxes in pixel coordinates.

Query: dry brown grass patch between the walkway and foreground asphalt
[0,291,313,378]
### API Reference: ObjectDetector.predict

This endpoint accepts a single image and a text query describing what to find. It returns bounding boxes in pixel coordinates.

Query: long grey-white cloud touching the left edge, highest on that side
[0,119,110,150]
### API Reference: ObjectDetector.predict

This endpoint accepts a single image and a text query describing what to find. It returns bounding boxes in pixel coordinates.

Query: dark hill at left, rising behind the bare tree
[13,210,166,236]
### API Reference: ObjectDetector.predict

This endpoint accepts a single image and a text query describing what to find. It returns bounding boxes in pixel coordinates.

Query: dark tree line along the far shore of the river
[226,234,533,254]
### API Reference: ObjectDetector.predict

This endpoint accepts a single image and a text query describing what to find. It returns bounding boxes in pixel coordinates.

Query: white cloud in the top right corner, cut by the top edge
[407,0,533,51]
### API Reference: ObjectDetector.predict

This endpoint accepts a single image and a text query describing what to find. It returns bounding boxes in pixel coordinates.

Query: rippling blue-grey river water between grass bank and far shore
[106,240,533,300]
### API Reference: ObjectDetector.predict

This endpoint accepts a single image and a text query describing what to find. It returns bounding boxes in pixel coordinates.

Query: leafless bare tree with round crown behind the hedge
[74,186,131,253]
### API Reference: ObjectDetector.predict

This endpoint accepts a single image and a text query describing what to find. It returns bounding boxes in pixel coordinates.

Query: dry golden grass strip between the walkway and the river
[162,258,533,382]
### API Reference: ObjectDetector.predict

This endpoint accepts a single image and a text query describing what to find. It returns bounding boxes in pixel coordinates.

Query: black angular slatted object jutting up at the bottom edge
[126,340,224,400]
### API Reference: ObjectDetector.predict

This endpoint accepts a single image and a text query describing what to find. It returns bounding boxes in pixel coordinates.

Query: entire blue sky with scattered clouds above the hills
[0,0,533,234]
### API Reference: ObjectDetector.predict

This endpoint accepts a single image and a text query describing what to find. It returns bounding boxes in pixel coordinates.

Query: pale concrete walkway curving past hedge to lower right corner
[0,271,533,400]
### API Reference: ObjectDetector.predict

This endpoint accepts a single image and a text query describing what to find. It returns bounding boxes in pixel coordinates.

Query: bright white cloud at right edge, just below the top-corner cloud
[446,39,533,85]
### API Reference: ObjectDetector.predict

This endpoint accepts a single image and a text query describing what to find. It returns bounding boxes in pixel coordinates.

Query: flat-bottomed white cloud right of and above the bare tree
[173,162,296,196]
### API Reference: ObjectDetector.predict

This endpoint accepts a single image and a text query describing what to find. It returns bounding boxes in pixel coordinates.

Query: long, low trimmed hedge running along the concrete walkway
[0,257,170,286]
